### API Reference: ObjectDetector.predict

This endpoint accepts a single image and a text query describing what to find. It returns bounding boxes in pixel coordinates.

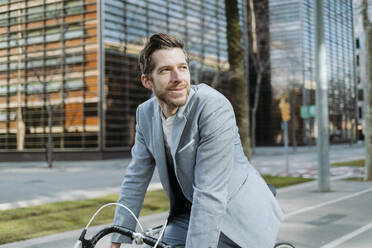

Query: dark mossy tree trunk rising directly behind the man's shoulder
[225,0,250,160]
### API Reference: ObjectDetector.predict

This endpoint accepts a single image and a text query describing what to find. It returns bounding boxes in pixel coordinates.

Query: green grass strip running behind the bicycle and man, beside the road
[0,176,311,244]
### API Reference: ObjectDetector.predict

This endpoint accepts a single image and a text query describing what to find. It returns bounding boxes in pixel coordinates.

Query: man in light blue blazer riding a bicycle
[111,34,282,248]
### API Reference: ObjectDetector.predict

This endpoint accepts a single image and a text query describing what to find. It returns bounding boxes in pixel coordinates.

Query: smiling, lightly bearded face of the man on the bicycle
[141,48,190,115]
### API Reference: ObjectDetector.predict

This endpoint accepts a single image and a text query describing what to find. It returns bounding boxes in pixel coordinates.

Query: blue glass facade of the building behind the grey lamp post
[270,0,356,144]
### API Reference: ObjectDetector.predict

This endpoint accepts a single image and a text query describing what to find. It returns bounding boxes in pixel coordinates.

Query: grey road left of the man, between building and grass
[0,159,159,210]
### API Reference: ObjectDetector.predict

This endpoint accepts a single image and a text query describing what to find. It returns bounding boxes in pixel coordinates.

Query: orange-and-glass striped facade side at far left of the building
[0,0,99,151]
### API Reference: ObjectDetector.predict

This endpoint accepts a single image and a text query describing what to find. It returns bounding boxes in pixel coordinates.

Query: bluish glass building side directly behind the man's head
[103,0,228,149]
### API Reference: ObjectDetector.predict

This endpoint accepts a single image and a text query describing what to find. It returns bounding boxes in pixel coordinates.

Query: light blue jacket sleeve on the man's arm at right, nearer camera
[186,96,236,248]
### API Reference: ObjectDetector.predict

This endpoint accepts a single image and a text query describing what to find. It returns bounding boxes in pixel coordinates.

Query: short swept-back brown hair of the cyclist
[139,33,189,78]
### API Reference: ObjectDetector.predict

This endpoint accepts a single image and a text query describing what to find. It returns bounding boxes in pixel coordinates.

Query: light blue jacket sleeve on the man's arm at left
[111,107,155,243]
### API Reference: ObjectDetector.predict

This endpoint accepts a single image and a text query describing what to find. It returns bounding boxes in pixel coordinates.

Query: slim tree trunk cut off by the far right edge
[362,0,372,181]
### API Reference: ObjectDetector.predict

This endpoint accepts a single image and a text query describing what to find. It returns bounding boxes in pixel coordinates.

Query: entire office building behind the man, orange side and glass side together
[0,0,235,152]
